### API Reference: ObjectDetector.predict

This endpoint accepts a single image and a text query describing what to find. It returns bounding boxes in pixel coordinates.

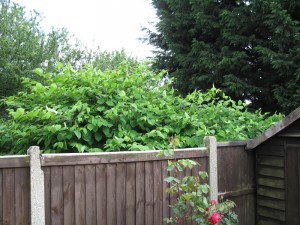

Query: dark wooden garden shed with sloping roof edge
[246,107,300,225]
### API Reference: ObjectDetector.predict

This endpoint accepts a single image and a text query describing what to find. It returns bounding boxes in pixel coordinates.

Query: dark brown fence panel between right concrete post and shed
[218,141,256,225]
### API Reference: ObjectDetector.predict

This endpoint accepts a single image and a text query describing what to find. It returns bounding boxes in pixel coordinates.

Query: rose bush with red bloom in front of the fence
[159,141,238,225]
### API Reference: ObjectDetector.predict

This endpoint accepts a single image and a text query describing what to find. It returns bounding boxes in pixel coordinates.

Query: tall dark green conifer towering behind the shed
[146,0,300,113]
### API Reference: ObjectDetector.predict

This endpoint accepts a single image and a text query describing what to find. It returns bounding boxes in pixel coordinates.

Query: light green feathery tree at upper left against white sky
[0,0,90,97]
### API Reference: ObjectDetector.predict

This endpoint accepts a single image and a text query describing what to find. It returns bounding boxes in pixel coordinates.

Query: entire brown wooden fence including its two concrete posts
[0,138,255,225]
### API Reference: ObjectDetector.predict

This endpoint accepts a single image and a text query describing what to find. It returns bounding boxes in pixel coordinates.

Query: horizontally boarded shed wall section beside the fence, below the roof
[256,136,286,225]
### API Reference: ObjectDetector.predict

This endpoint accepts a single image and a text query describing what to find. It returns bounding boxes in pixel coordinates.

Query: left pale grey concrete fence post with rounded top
[27,146,45,225]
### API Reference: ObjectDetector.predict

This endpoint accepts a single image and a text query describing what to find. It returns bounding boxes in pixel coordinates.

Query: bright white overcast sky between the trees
[14,0,157,58]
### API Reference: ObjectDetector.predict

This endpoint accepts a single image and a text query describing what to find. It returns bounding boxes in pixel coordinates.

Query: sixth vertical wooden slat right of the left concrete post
[96,164,107,225]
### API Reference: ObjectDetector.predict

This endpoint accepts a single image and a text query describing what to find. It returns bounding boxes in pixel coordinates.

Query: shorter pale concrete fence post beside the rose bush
[204,136,218,202]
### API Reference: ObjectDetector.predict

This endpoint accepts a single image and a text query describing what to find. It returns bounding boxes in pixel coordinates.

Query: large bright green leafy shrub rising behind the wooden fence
[0,62,281,154]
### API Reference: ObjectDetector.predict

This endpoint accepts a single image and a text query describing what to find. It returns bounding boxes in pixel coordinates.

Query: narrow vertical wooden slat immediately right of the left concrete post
[43,167,51,225]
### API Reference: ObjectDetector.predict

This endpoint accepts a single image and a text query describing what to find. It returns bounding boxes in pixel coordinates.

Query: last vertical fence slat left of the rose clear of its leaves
[153,161,163,225]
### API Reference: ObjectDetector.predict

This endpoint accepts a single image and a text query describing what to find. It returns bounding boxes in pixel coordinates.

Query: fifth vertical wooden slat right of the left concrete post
[85,165,97,225]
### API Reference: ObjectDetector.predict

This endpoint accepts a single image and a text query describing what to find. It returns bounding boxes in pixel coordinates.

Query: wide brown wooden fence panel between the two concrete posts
[42,148,208,225]
